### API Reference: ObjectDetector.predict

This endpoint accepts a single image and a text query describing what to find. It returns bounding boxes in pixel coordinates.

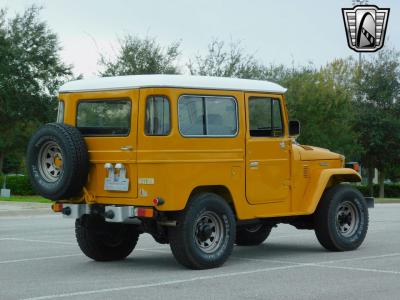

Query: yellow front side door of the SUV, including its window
[245,93,290,204]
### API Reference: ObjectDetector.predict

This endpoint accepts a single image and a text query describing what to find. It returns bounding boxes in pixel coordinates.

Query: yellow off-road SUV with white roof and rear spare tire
[27,75,374,269]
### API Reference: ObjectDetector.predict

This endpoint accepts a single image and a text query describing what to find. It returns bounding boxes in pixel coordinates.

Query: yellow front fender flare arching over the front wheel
[305,168,361,214]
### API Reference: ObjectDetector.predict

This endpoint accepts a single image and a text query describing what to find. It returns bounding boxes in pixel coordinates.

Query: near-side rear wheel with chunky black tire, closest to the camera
[169,193,236,269]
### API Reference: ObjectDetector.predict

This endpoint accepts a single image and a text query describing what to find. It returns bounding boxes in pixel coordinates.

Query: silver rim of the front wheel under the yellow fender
[336,201,360,237]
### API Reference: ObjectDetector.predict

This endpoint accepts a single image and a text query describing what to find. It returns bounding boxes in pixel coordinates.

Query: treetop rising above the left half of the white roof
[99,35,180,76]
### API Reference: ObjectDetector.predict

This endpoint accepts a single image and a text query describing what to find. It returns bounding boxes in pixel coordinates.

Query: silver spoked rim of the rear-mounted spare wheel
[38,141,63,182]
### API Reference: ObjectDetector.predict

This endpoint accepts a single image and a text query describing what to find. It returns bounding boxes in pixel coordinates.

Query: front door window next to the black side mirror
[249,97,283,137]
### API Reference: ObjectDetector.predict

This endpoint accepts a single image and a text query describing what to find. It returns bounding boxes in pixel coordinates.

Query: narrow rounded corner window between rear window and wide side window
[145,96,171,135]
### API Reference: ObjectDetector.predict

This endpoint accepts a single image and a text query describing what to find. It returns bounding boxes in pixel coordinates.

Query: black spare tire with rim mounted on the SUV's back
[27,123,89,200]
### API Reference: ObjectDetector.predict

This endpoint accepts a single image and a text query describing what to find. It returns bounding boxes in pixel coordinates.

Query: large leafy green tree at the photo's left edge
[0,6,71,172]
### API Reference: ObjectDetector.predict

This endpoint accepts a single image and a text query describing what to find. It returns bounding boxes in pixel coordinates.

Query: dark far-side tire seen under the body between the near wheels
[235,224,272,246]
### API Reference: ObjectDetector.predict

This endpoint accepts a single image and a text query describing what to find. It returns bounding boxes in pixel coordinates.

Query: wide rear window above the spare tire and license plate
[76,99,131,136]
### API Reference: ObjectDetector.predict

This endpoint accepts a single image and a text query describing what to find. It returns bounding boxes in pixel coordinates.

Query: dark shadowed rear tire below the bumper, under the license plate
[75,215,139,261]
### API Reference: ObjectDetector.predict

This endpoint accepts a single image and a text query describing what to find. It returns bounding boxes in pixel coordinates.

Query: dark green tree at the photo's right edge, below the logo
[354,49,400,197]
